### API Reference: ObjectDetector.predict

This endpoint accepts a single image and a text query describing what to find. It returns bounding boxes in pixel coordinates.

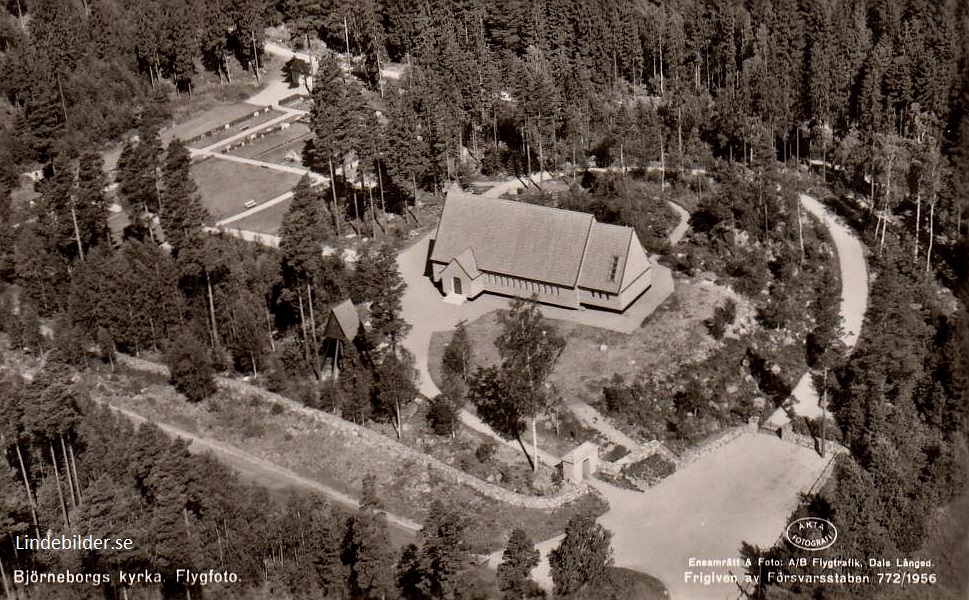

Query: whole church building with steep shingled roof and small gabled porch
[429,192,652,312]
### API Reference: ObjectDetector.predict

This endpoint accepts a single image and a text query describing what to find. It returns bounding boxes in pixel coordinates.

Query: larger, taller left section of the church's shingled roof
[431,192,592,287]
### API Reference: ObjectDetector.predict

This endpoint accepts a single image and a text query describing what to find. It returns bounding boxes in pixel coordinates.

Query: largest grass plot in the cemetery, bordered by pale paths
[192,158,300,220]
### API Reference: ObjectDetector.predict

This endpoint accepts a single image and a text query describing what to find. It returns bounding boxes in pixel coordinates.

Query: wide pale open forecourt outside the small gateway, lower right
[489,433,830,600]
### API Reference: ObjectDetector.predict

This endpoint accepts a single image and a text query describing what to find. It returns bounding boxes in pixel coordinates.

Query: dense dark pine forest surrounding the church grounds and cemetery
[0,0,969,599]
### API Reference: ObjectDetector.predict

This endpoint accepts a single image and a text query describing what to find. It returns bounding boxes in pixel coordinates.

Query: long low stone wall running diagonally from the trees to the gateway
[118,354,594,509]
